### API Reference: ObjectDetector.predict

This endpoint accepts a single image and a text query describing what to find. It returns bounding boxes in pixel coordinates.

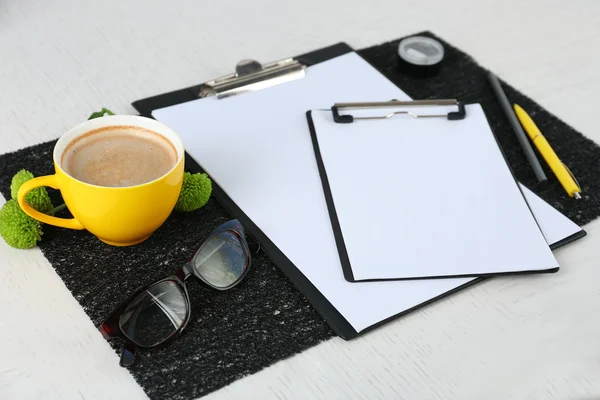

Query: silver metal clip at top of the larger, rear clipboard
[199,58,306,99]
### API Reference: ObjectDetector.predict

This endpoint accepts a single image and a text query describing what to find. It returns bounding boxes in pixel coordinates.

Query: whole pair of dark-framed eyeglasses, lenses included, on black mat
[99,220,251,367]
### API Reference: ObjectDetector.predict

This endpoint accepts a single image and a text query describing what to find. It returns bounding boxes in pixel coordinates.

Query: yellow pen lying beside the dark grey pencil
[513,104,581,199]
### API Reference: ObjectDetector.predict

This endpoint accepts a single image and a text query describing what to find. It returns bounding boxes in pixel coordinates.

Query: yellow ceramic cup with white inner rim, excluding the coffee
[17,115,185,246]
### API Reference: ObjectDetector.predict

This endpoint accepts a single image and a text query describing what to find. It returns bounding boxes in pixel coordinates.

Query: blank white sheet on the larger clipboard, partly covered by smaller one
[153,53,565,332]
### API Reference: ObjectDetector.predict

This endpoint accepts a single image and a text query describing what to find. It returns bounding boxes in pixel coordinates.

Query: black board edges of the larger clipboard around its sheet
[132,43,586,340]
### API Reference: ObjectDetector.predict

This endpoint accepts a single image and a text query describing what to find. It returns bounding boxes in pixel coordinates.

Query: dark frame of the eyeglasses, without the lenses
[98,219,253,367]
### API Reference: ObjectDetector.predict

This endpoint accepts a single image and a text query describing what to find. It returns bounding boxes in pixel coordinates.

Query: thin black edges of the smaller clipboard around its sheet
[306,106,585,283]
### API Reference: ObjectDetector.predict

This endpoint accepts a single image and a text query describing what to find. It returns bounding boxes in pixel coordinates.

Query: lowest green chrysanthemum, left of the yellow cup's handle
[0,199,42,249]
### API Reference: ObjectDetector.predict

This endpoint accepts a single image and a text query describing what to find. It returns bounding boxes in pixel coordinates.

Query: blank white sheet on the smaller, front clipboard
[312,104,558,281]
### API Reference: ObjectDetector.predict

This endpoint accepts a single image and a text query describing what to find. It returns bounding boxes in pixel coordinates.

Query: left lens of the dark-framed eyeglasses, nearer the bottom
[119,281,189,347]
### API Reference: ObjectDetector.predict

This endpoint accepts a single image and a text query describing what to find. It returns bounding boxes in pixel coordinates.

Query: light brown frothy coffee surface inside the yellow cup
[61,126,177,187]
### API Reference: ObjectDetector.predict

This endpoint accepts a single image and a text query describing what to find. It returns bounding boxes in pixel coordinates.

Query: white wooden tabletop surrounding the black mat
[0,0,600,400]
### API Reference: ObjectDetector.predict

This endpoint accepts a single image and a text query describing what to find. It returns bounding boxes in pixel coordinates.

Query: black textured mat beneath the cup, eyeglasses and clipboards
[0,32,600,399]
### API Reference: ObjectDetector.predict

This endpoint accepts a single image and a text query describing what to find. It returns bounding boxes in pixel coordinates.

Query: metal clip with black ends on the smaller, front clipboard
[331,99,467,124]
